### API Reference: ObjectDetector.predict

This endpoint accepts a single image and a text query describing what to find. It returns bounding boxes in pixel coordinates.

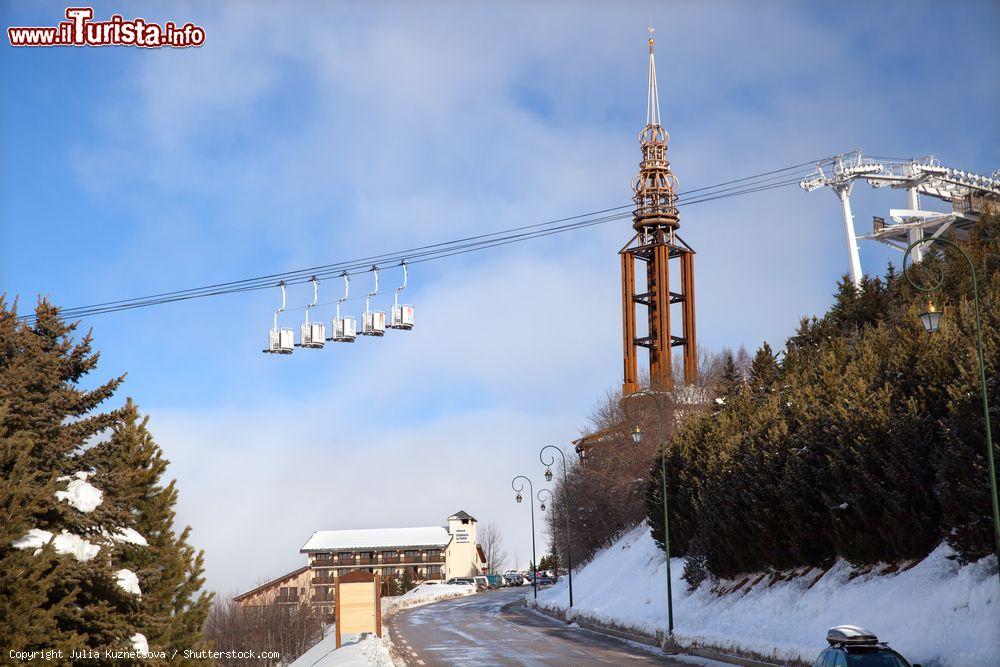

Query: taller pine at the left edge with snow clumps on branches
[0,299,209,650]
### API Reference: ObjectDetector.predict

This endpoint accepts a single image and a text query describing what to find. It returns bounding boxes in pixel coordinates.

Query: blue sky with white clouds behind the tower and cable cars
[0,1,1000,593]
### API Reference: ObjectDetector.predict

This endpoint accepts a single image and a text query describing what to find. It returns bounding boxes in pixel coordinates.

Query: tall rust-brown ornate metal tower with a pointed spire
[619,27,698,396]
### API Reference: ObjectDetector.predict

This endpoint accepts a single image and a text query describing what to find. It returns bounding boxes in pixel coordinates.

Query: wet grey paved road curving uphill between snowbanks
[387,589,691,667]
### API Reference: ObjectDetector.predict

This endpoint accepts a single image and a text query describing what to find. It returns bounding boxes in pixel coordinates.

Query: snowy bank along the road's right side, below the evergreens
[538,524,1000,667]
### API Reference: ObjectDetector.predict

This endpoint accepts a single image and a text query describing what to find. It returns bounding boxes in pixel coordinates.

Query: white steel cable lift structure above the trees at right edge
[799,150,1000,287]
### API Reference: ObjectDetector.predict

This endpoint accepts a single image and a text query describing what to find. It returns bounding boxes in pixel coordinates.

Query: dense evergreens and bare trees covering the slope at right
[549,216,1000,583]
